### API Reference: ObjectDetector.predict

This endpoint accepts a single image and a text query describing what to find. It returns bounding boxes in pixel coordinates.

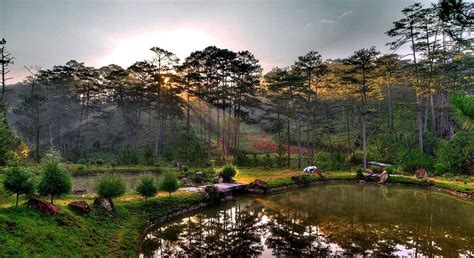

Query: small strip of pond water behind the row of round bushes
[72,172,162,195]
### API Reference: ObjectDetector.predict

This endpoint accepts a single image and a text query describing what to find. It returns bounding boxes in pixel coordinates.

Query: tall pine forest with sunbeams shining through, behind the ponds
[1,1,474,173]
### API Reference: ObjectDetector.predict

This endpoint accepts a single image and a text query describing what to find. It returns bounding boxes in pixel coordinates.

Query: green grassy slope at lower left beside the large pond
[0,193,202,257]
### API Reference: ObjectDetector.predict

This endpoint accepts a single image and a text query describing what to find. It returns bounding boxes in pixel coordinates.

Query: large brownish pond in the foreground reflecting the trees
[139,185,474,257]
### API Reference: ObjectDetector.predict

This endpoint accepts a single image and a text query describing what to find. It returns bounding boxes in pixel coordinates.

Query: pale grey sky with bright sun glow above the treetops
[0,0,435,83]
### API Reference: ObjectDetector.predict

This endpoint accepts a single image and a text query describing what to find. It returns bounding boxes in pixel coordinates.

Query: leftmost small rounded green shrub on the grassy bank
[3,167,35,207]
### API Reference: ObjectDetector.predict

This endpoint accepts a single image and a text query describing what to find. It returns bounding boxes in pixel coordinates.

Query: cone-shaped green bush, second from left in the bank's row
[38,152,72,204]
